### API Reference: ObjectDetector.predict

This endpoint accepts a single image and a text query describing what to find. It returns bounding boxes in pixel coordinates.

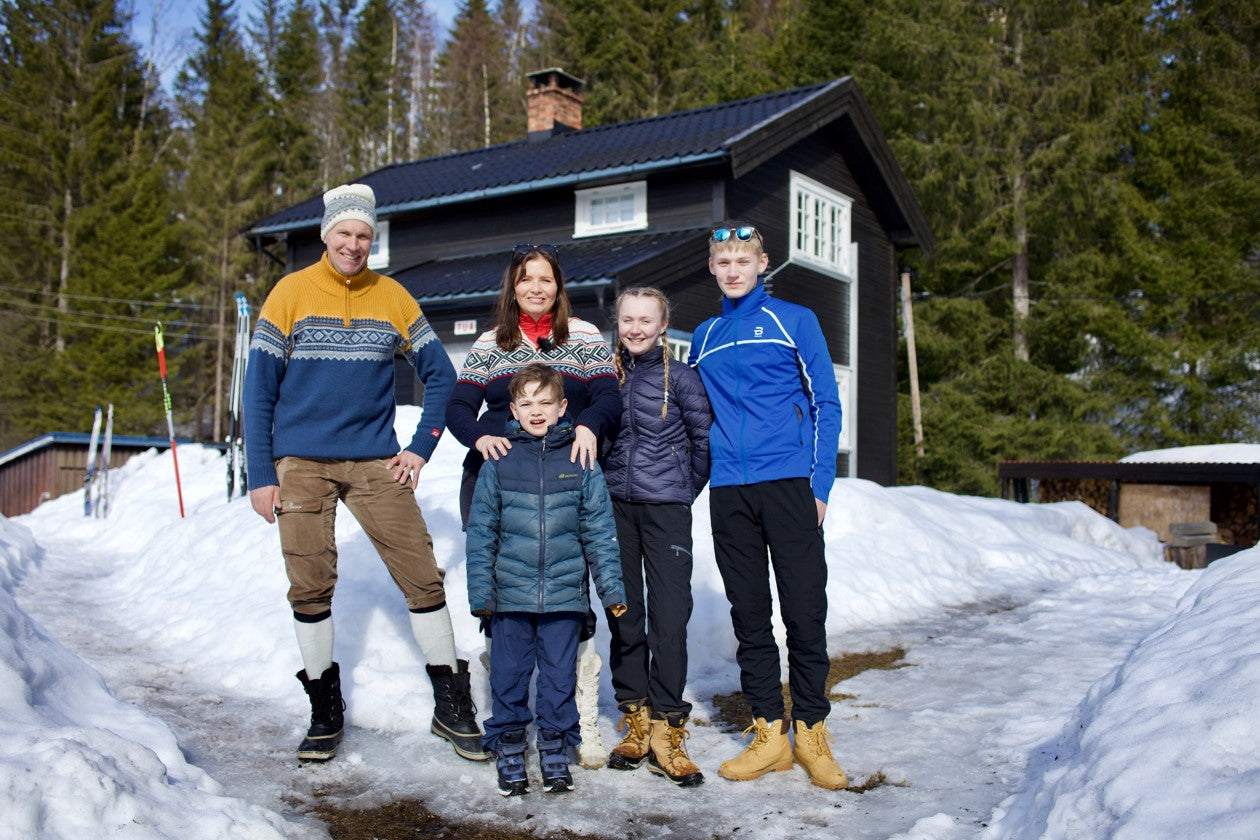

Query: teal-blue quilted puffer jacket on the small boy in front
[465,417,625,615]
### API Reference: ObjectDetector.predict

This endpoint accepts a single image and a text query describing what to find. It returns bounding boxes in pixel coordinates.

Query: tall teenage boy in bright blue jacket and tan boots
[688,222,848,790]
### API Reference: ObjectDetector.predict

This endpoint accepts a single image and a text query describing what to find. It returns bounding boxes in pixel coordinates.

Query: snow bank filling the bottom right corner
[983,549,1260,840]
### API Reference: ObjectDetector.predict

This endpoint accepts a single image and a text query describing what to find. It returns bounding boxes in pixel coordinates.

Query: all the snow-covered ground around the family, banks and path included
[0,409,1260,840]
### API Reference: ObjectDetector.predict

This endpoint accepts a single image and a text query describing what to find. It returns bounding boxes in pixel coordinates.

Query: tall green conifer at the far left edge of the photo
[0,0,180,446]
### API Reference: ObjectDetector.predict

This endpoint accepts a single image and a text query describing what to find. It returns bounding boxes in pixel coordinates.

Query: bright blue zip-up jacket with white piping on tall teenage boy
[687,282,840,502]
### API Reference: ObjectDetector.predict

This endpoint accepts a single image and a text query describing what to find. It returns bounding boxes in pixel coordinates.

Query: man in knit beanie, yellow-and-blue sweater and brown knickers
[244,184,489,761]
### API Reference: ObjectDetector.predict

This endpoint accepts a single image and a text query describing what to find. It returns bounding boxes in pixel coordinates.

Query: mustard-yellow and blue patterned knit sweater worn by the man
[244,254,455,490]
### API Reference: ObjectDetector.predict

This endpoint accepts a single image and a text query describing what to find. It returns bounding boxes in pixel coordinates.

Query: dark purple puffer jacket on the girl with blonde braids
[604,348,713,505]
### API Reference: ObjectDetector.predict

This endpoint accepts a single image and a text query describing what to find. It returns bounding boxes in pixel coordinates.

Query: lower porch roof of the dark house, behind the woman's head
[389,228,709,306]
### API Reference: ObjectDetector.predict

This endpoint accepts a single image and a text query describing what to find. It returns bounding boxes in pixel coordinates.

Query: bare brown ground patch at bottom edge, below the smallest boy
[311,800,599,840]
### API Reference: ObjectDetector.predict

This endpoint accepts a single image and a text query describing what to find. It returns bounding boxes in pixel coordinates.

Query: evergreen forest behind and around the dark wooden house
[0,0,1260,494]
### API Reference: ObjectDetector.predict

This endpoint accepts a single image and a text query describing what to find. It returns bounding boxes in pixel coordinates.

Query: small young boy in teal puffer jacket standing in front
[466,364,626,796]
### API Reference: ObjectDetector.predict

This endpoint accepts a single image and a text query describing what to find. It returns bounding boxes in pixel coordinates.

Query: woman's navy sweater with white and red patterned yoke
[446,317,621,472]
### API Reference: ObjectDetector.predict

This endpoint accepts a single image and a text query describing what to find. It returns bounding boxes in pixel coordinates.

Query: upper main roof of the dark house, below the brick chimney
[244,77,935,252]
